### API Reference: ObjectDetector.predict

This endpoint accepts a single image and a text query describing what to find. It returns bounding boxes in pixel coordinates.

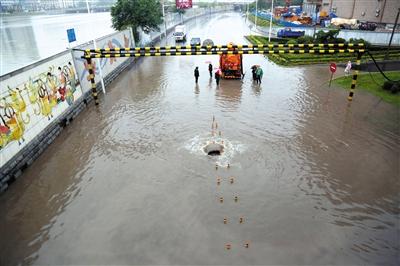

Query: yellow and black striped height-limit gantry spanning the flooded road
[81,43,366,105]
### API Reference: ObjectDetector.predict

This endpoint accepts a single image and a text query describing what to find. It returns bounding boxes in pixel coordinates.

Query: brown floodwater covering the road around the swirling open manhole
[0,11,400,265]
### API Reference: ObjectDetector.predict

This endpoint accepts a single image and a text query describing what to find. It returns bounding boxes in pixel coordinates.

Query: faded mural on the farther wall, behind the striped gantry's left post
[74,30,133,89]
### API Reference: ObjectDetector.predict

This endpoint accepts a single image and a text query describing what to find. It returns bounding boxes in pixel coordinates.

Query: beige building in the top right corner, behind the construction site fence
[303,0,400,24]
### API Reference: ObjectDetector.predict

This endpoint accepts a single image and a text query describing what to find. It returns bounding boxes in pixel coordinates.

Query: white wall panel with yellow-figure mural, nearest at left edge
[0,52,82,167]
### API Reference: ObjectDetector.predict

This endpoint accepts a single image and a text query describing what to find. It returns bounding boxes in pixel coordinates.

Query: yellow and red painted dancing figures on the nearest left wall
[0,62,79,150]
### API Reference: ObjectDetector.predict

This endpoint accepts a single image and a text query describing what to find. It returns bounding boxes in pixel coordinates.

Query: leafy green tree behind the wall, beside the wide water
[111,0,163,40]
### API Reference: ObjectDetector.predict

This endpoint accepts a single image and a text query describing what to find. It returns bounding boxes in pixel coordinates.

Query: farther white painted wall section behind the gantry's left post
[73,30,134,92]
